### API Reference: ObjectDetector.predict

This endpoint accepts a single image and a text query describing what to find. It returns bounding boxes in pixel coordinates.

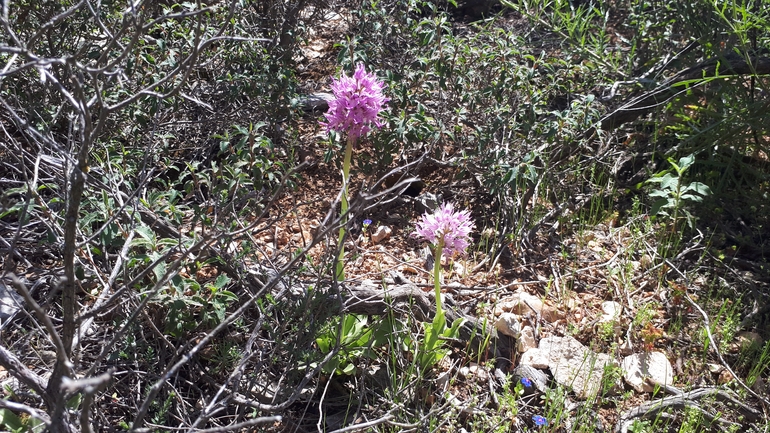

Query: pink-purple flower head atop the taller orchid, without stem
[321,63,389,140]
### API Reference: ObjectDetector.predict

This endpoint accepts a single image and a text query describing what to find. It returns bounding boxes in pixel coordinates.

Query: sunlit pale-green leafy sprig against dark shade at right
[647,155,711,232]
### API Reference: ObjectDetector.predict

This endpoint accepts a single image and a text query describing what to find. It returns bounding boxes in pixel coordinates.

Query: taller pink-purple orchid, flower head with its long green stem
[321,63,389,281]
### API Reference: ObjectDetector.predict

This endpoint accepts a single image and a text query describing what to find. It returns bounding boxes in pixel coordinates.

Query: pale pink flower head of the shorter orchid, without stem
[412,203,474,260]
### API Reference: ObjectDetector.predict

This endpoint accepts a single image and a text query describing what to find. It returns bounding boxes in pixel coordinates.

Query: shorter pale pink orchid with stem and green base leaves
[412,203,474,368]
